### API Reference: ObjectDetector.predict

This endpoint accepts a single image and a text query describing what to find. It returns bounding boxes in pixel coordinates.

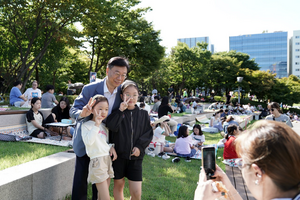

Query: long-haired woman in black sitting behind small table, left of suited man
[45,97,74,139]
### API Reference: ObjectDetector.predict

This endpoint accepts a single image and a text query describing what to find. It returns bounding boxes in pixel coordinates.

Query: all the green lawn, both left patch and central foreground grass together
[0,130,225,200]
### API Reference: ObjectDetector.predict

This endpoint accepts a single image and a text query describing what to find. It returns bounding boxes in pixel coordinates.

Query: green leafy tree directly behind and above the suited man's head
[82,0,164,81]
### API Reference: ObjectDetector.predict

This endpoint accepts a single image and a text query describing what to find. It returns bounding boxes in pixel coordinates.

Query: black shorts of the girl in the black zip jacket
[113,157,143,181]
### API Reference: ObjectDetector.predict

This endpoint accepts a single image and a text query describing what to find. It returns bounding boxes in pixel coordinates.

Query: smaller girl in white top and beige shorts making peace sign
[81,95,117,200]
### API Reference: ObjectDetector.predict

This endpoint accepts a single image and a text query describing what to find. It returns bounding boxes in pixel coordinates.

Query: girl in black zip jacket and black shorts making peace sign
[106,80,153,200]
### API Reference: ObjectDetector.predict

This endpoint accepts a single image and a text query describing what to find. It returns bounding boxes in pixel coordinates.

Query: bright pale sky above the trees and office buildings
[138,0,300,51]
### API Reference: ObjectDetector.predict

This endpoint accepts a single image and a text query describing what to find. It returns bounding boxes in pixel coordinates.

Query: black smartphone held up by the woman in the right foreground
[202,147,216,180]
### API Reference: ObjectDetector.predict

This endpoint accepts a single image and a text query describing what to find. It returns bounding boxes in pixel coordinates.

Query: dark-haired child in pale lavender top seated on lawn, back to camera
[174,125,198,157]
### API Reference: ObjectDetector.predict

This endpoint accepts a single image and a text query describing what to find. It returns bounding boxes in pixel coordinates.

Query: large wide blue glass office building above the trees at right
[229,32,288,78]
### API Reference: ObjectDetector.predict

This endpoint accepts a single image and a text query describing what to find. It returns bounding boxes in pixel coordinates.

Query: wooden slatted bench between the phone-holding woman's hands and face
[225,165,255,200]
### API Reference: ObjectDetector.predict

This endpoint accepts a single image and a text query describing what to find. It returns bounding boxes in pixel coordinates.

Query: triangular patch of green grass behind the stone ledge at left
[0,141,70,170]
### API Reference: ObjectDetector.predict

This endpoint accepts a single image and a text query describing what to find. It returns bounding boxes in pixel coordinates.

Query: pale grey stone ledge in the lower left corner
[0,152,76,200]
